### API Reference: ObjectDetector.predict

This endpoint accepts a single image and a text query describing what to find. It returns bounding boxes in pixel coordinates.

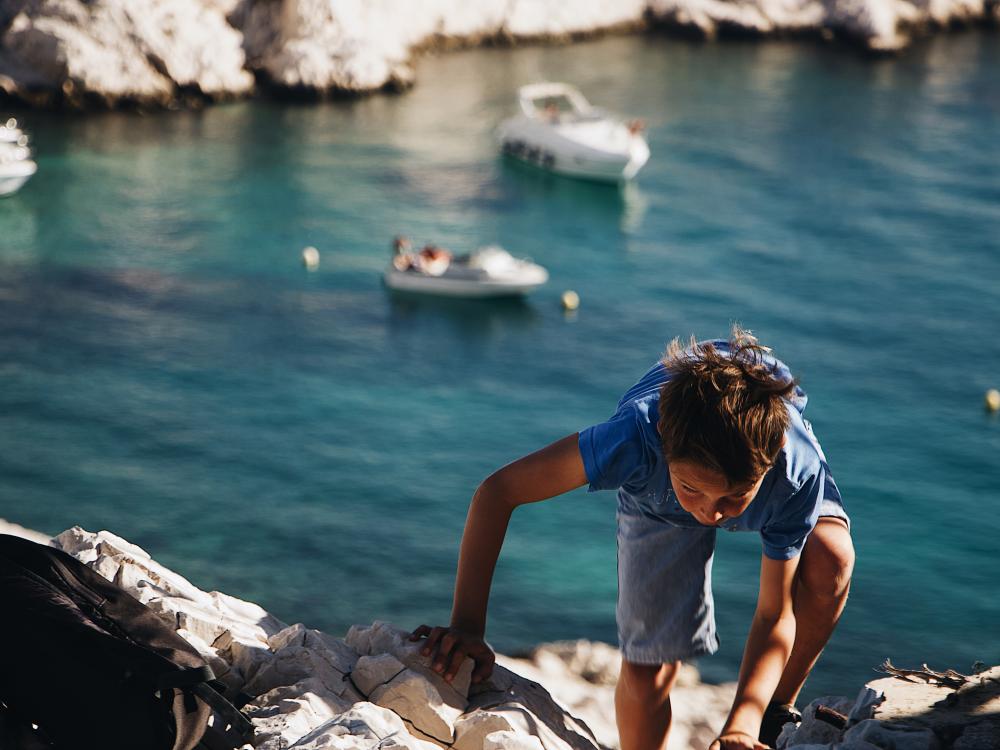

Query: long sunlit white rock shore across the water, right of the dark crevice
[230,0,990,101]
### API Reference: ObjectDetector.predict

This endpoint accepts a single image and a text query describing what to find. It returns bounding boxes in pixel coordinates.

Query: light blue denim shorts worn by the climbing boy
[616,499,851,664]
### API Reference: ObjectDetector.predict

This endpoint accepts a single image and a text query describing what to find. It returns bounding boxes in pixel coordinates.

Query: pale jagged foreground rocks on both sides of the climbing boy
[0,520,1000,750]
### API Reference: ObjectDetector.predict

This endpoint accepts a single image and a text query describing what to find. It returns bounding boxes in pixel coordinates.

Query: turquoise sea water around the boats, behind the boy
[0,32,1000,695]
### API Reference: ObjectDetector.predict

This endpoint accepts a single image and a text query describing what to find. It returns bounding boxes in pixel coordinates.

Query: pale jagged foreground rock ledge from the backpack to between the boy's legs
[29,523,734,750]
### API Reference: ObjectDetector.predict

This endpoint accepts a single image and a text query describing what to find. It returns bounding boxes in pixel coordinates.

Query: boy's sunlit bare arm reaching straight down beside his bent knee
[710,555,799,750]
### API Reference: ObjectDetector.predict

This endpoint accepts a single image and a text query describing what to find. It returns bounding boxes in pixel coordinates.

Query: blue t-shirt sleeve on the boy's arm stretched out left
[579,409,649,492]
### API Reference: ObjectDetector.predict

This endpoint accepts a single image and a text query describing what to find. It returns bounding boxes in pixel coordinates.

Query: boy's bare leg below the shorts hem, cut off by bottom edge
[615,659,681,750]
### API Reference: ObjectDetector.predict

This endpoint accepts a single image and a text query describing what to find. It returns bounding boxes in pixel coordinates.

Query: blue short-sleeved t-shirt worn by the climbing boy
[579,341,840,560]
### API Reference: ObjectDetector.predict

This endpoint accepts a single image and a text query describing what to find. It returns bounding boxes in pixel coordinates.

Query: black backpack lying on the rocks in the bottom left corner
[0,534,253,750]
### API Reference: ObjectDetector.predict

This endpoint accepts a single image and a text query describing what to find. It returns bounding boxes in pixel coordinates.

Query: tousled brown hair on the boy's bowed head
[658,325,796,485]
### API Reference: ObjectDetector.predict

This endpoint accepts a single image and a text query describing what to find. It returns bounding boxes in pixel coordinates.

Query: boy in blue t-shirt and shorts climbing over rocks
[412,326,854,750]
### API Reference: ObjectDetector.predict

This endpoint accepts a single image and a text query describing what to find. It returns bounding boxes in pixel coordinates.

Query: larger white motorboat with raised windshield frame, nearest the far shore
[497,83,649,182]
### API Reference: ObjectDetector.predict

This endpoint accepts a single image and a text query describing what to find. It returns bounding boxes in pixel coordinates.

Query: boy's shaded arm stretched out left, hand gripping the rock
[410,432,587,682]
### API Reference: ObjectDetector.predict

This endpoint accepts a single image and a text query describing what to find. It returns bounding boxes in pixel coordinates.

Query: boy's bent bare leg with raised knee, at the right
[773,517,854,704]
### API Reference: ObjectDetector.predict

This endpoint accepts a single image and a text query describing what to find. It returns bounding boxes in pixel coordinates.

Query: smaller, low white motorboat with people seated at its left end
[382,245,549,297]
